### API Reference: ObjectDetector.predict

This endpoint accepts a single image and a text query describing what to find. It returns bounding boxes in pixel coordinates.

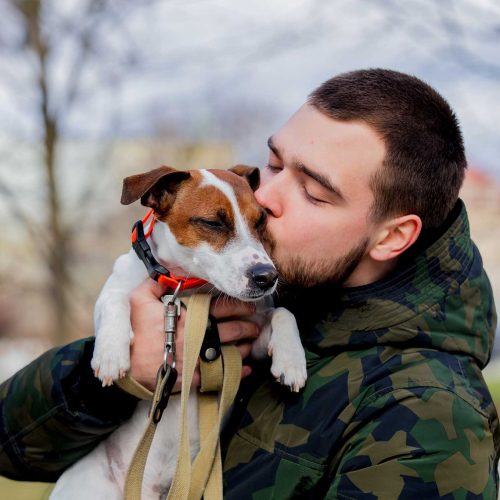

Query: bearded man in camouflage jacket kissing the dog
[0,70,499,499]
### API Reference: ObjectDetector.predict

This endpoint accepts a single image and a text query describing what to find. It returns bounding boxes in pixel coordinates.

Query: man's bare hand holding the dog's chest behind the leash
[130,279,260,392]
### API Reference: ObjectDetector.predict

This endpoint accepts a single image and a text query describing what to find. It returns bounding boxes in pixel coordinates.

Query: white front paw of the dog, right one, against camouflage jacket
[269,339,307,392]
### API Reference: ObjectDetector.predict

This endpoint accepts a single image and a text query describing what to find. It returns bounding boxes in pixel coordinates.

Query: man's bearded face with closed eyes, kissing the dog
[255,104,385,286]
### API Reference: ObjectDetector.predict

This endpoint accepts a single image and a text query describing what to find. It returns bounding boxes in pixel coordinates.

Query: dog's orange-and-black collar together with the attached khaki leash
[117,213,241,500]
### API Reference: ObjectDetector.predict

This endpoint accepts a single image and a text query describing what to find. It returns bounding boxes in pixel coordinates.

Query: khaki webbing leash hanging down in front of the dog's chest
[118,294,241,500]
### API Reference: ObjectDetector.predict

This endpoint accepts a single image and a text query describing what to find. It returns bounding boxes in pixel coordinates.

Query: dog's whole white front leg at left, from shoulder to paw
[92,250,147,385]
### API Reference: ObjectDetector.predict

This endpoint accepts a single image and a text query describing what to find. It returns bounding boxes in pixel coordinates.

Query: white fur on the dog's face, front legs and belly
[51,170,307,500]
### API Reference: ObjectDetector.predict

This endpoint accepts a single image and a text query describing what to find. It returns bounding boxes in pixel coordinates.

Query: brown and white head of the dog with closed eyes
[121,165,278,300]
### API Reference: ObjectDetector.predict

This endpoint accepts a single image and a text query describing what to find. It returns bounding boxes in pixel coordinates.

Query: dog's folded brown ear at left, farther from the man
[121,166,191,213]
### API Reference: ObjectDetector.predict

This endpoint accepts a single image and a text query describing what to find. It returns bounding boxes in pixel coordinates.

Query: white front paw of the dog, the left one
[90,338,130,387]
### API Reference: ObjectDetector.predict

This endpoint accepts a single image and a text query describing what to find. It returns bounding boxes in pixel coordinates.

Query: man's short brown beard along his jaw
[264,231,368,292]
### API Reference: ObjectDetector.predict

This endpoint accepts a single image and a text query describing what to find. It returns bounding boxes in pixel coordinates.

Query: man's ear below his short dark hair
[368,215,422,261]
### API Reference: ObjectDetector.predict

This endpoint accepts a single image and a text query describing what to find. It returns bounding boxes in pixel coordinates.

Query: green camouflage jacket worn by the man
[0,202,500,500]
